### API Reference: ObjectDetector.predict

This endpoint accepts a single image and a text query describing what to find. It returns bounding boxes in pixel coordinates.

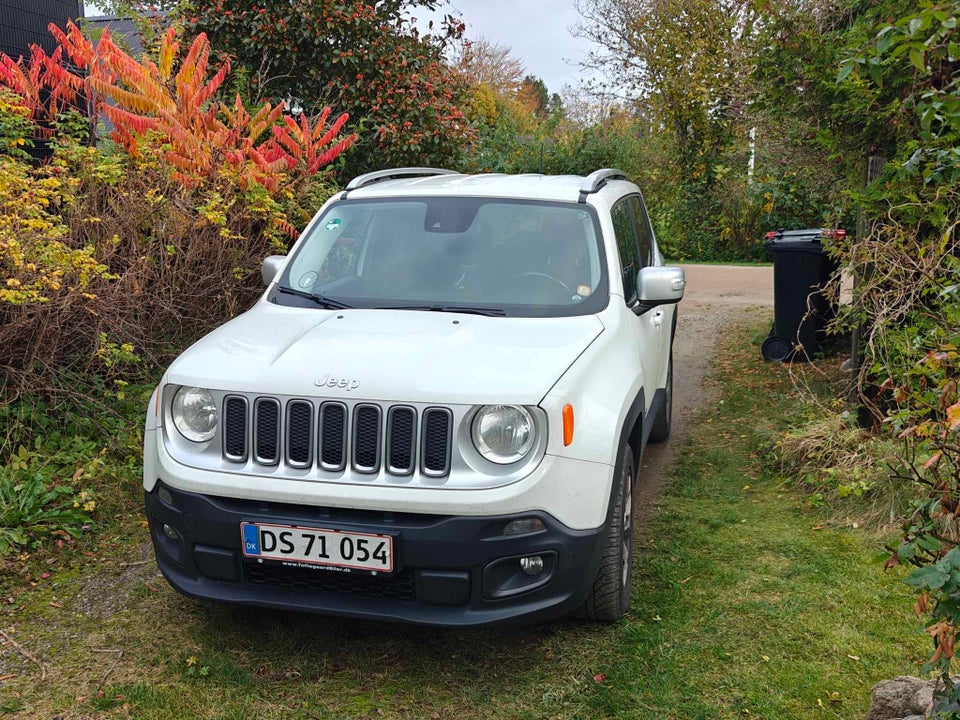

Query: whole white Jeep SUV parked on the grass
[143,168,684,625]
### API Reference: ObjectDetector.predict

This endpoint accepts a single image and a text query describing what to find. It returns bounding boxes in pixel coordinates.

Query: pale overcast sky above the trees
[85,0,590,93]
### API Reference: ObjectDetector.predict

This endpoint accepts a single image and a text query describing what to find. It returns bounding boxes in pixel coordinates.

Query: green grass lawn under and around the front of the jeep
[0,328,928,720]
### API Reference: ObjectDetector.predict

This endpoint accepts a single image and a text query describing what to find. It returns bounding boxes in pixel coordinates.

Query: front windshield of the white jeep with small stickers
[272,197,607,317]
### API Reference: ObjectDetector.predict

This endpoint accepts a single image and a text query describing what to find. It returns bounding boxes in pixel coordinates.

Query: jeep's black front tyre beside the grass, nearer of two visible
[583,444,636,622]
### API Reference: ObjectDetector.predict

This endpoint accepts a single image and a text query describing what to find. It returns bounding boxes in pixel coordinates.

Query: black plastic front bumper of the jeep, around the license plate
[145,483,604,626]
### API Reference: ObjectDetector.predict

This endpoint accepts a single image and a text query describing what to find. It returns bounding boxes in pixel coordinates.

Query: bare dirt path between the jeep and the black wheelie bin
[635,265,773,528]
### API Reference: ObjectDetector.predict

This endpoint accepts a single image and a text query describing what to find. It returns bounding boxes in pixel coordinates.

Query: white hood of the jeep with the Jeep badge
[166,301,603,405]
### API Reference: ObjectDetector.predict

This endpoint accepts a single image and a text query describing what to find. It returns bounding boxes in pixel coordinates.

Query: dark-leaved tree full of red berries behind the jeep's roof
[179,0,471,175]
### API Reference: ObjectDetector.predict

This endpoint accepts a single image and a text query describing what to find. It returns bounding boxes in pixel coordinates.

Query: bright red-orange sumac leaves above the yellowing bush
[36,23,356,190]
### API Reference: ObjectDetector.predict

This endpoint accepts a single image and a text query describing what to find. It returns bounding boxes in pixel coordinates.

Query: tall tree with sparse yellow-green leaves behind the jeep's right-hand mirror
[577,0,763,259]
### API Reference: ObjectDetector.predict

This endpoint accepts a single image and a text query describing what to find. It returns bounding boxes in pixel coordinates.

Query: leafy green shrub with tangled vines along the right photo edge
[812,2,960,696]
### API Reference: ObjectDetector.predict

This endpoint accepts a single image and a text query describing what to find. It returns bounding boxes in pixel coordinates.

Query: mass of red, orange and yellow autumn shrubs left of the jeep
[0,25,355,399]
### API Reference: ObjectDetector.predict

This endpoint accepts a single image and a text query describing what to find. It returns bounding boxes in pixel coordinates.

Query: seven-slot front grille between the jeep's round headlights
[222,395,453,479]
